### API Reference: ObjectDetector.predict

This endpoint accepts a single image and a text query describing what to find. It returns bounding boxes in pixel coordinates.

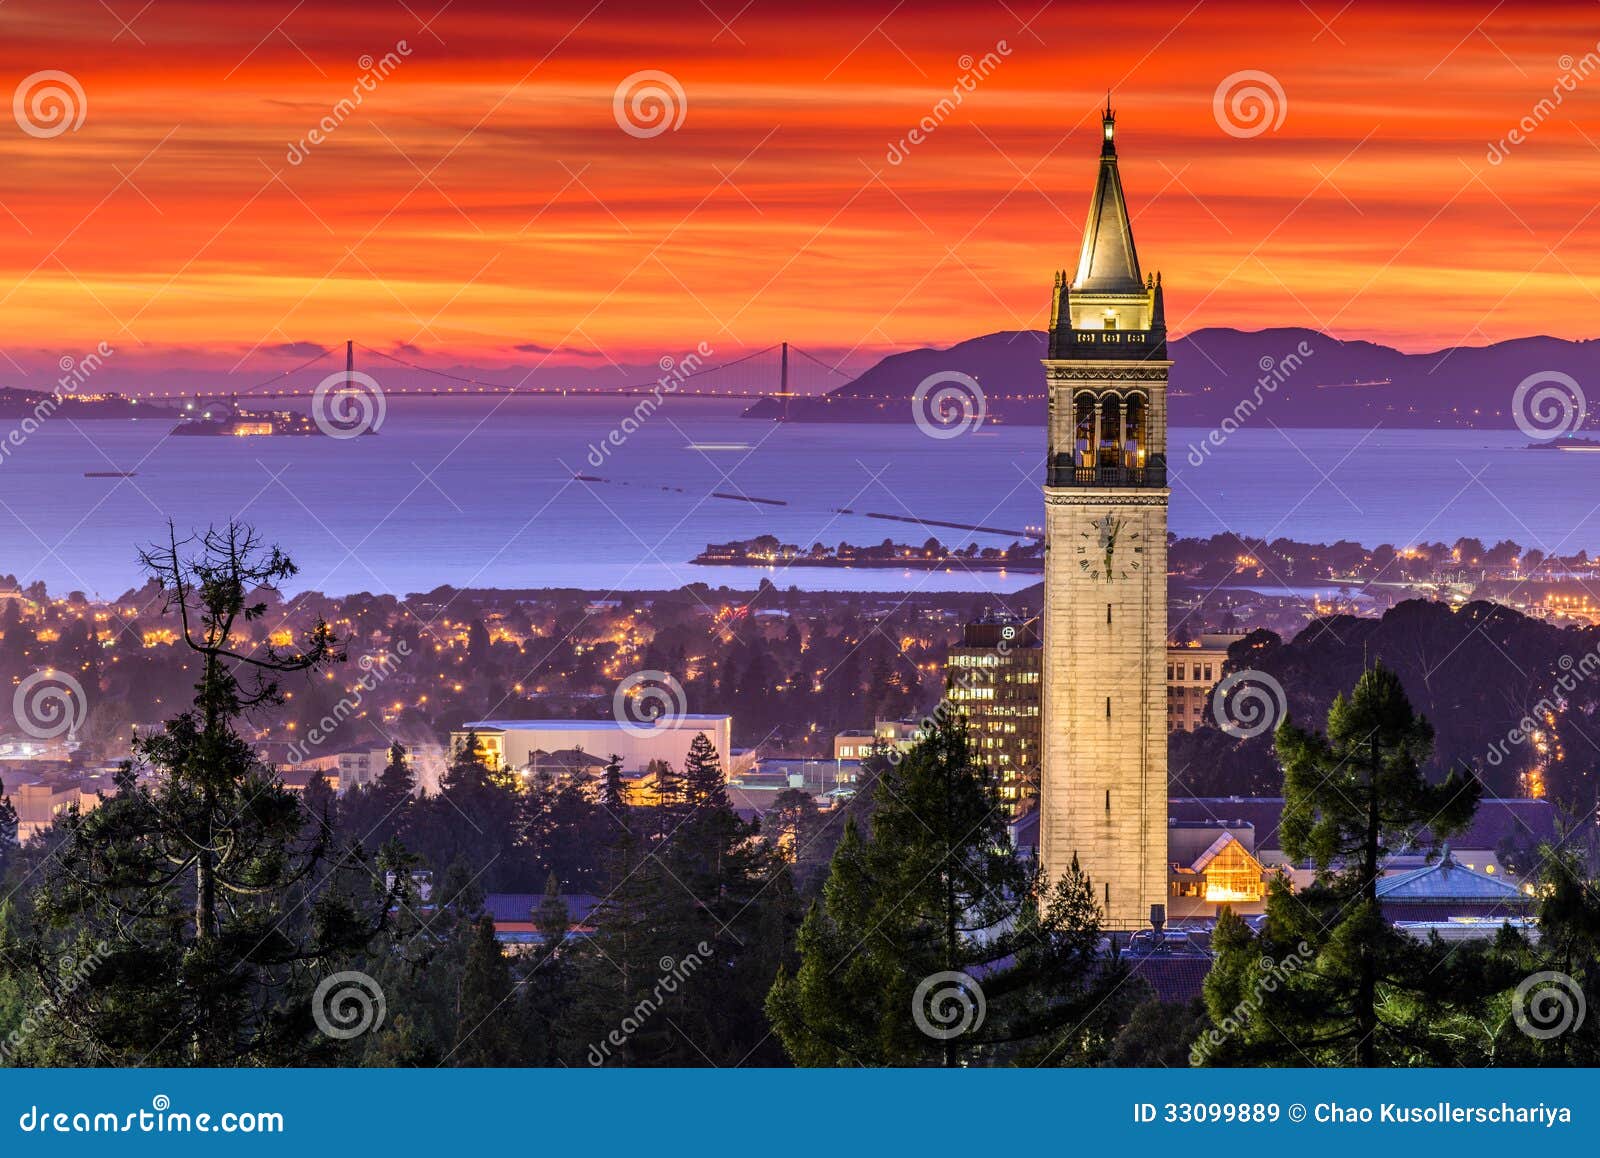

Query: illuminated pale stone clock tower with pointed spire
[1038,102,1171,929]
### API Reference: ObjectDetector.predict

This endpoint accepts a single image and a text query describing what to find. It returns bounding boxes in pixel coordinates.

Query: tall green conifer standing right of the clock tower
[1206,664,1483,1065]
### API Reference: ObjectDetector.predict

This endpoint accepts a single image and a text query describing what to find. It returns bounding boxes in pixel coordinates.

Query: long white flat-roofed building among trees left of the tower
[450,715,733,773]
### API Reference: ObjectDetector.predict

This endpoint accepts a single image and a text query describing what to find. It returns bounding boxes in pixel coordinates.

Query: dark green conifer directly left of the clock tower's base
[766,718,1134,1065]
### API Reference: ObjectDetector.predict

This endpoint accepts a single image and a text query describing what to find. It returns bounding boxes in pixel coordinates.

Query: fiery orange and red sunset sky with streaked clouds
[0,0,1600,385]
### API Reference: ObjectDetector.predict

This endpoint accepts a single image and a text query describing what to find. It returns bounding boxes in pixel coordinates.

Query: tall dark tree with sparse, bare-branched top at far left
[13,523,392,1065]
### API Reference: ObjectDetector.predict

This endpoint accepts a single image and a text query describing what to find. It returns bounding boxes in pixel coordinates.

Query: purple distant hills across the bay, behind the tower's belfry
[746,328,1600,430]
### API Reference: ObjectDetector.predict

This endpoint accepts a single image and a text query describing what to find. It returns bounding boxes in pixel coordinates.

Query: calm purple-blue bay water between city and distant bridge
[0,398,1600,597]
